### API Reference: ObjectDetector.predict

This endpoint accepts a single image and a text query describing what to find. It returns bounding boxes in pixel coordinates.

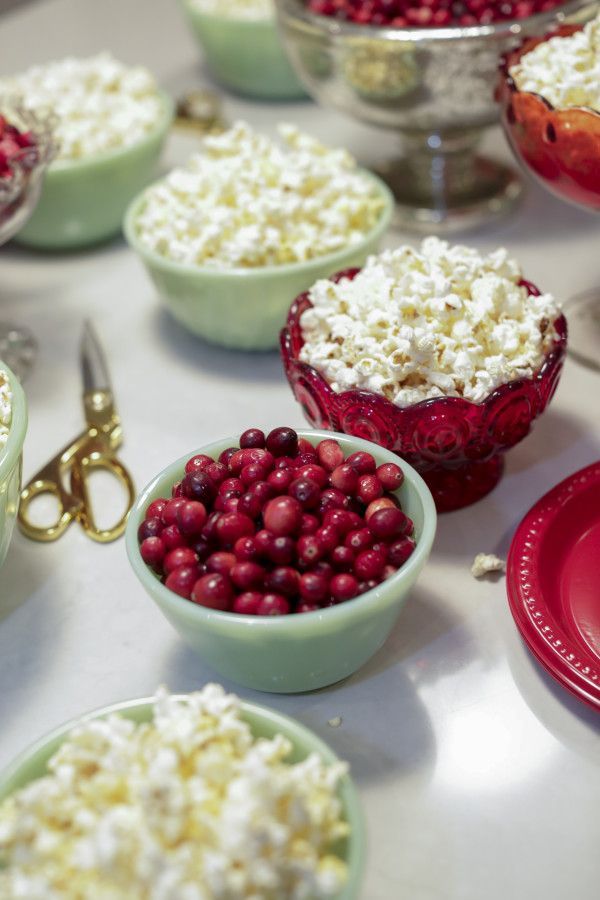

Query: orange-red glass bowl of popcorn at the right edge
[497,25,600,210]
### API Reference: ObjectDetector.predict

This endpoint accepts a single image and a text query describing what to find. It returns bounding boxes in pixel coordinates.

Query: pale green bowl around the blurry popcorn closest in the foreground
[0,698,366,900]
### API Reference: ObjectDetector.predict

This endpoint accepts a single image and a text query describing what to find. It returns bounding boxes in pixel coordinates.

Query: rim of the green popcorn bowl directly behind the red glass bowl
[123,167,395,281]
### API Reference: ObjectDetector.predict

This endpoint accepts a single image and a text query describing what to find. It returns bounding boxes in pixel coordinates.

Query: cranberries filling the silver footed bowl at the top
[307,0,564,28]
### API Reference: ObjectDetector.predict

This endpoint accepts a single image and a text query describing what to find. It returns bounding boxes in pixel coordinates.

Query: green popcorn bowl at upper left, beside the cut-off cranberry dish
[15,91,174,250]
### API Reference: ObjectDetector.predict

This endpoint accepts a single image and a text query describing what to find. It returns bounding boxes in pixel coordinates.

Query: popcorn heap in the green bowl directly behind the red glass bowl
[136,122,384,269]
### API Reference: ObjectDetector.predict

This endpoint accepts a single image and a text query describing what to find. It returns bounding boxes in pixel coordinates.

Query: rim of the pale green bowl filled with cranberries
[125,429,437,634]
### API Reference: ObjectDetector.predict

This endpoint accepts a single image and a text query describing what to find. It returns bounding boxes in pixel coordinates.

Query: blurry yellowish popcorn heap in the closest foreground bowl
[0,684,348,900]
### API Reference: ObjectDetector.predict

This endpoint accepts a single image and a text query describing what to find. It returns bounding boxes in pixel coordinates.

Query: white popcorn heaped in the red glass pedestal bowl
[300,237,559,407]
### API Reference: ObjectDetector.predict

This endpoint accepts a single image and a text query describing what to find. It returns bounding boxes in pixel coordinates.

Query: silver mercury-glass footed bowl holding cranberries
[275,0,597,233]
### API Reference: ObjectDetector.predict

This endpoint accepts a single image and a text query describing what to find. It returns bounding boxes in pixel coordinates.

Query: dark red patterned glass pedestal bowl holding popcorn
[281,269,567,512]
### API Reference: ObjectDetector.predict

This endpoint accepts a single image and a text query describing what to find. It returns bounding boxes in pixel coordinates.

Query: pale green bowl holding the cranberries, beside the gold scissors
[126,430,436,693]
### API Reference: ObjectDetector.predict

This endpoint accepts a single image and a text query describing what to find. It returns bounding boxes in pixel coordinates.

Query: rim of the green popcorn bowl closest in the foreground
[0,692,367,896]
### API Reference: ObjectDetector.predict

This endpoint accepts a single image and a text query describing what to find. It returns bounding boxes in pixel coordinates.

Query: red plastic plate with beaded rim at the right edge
[507,462,600,710]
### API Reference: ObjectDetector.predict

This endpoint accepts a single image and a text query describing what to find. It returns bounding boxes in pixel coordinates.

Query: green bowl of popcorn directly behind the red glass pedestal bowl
[124,172,394,350]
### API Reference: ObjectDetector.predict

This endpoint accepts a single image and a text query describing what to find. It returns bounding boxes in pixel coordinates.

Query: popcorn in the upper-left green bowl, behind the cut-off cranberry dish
[0,53,164,160]
